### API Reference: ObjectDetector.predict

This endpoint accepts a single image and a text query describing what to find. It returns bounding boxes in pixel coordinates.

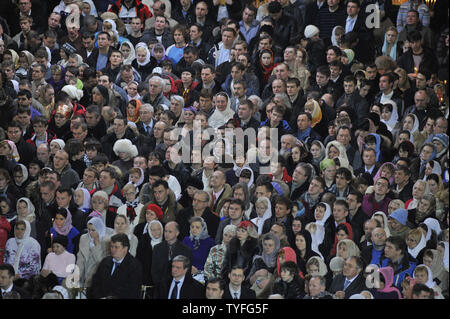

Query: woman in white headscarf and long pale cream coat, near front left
[77,217,112,288]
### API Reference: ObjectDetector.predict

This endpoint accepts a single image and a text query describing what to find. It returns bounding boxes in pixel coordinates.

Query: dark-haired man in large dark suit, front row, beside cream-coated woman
[88,234,143,299]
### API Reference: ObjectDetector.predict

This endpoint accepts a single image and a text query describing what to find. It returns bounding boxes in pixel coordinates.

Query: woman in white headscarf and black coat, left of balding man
[136,219,164,286]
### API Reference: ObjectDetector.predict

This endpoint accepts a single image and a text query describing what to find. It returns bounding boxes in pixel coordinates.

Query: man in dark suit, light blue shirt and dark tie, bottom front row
[155,255,205,299]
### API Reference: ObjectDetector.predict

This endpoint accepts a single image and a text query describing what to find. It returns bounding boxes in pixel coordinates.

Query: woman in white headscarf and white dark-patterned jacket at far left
[4,219,41,279]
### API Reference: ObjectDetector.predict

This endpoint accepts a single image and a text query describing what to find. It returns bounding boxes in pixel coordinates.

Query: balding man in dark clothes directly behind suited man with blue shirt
[152,222,192,288]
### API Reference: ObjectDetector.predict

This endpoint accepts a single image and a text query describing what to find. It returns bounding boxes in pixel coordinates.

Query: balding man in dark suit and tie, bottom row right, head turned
[330,256,366,299]
